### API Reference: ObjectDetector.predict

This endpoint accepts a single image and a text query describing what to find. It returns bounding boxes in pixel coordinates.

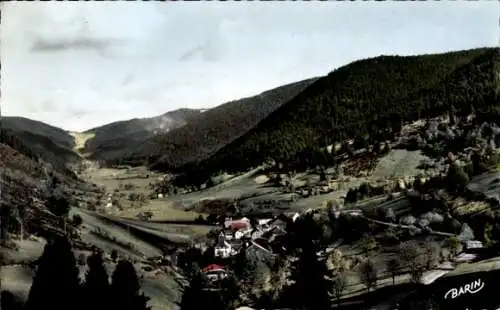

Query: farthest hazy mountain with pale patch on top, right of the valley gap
[83,109,201,160]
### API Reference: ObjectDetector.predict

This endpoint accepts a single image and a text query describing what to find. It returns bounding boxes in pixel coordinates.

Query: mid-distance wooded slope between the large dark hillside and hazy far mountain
[111,78,316,169]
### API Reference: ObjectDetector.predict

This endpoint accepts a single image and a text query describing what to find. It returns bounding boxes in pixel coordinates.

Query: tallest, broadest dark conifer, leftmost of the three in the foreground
[25,237,81,310]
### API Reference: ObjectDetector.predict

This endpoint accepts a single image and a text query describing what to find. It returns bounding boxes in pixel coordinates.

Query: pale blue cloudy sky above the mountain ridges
[0,1,500,131]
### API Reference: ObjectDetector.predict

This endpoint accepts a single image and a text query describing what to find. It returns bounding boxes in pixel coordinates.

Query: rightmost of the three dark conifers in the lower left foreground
[111,260,151,310]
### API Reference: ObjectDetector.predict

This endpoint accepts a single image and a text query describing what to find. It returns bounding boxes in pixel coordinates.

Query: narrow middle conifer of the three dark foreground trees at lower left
[83,252,110,310]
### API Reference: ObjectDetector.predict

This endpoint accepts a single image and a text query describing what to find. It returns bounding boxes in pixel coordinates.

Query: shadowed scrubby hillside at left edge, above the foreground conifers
[0,128,79,243]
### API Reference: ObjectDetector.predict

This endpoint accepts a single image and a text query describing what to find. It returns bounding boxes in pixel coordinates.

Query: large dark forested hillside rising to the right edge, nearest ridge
[177,48,498,183]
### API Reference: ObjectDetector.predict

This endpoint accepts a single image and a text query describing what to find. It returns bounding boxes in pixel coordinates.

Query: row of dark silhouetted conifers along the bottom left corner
[1,237,151,310]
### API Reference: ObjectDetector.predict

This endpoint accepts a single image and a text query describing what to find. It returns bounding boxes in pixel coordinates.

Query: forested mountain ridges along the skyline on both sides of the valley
[2,48,499,181]
